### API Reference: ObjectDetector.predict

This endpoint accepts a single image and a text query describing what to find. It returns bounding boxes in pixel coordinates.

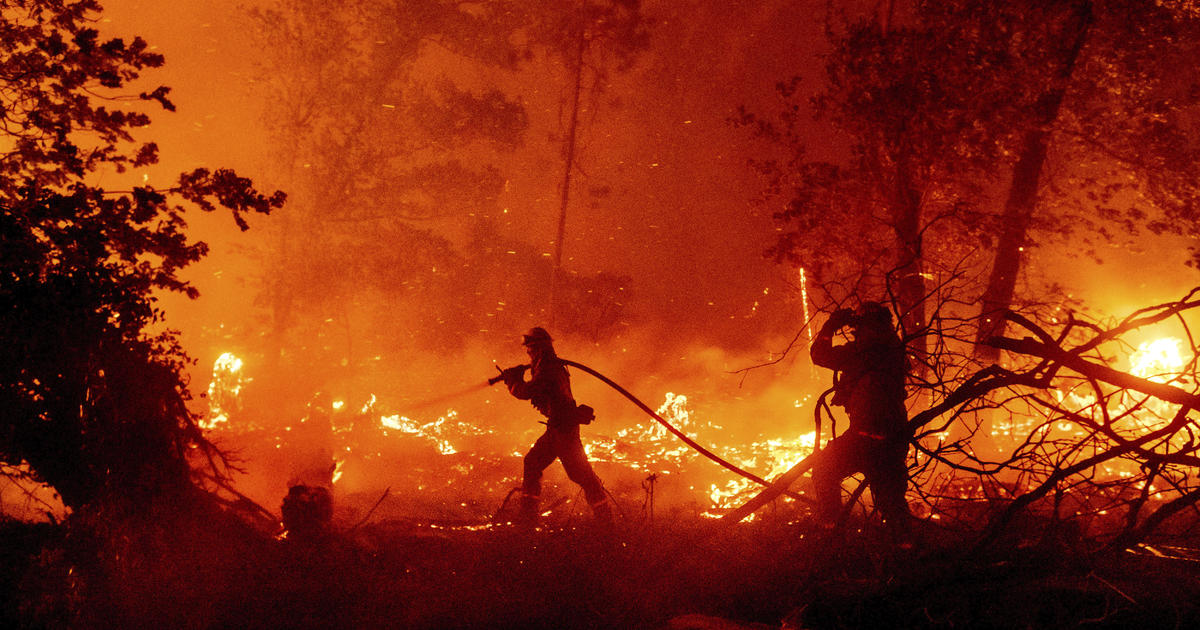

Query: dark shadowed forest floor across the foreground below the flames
[7,501,1200,629]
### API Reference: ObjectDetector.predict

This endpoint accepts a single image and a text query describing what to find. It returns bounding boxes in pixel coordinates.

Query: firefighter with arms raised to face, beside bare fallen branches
[811,302,911,538]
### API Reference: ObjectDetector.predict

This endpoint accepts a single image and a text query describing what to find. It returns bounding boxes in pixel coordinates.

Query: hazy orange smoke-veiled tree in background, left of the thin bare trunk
[252,0,528,370]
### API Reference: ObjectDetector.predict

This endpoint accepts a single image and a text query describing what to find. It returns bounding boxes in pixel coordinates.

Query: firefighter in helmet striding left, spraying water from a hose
[491,328,612,524]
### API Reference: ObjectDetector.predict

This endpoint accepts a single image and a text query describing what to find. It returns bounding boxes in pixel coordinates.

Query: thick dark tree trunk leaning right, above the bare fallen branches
[974,0,1093,361]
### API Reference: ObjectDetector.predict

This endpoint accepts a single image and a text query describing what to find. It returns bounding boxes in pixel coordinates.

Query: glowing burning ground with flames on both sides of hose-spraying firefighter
[205,338,835,526]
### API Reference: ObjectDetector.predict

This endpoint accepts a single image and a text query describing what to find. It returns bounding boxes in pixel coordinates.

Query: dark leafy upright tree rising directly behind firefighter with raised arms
[736,3,1016,369]
